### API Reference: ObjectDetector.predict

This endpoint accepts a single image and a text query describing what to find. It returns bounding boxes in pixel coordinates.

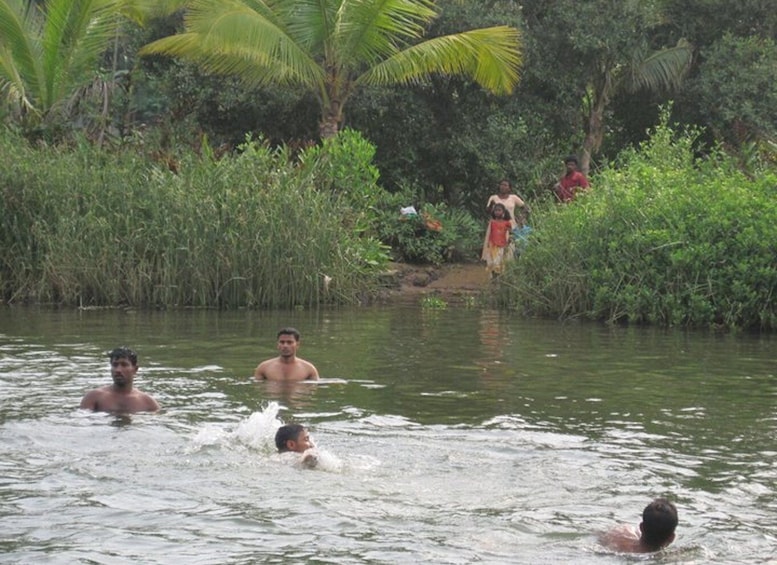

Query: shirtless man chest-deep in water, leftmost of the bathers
[81,347,159,414]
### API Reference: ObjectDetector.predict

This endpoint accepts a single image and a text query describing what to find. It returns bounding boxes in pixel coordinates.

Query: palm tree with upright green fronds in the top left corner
[0,0,181,135]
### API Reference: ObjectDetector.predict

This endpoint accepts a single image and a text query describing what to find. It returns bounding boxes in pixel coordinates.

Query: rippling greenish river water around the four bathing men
[0,306,777,564]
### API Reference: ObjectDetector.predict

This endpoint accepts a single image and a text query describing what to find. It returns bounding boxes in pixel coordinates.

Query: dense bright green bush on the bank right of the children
[502,113,777,329]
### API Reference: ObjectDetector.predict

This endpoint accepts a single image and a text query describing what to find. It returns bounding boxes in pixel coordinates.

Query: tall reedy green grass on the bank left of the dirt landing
[0,132,388,308]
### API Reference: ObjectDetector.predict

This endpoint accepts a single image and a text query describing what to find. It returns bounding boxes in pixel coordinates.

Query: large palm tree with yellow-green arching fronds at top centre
[141,0,521,138]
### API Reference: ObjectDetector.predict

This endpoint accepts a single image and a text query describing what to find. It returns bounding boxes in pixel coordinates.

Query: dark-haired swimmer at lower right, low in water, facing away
[599,498,677,553]
